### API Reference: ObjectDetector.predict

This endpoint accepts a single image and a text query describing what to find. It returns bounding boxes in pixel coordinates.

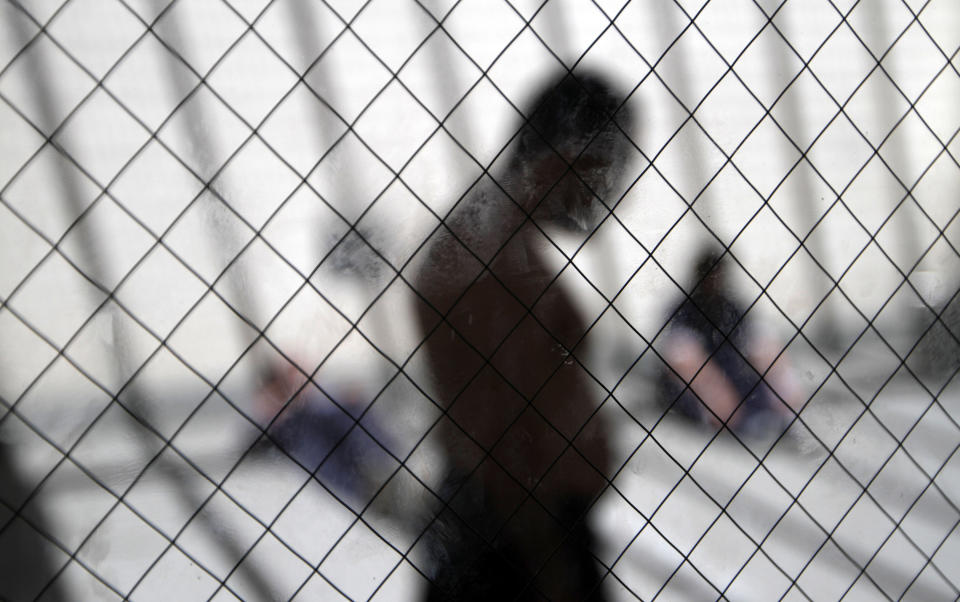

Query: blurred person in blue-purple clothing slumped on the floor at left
[257,361,395,509]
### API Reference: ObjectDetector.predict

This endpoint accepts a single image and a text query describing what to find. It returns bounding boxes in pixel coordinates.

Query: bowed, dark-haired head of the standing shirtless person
[511,72,631,231]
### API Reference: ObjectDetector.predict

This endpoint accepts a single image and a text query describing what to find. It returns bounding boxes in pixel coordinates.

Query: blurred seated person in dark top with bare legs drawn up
[660,249,797,437]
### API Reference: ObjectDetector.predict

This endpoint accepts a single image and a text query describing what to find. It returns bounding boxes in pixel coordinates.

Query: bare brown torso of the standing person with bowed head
[416,177,607,597]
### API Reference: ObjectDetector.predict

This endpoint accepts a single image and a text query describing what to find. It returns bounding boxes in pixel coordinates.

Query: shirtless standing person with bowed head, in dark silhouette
[415,71,625,600]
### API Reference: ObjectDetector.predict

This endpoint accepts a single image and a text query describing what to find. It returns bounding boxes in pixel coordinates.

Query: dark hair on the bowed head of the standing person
[513,71,632,169]
